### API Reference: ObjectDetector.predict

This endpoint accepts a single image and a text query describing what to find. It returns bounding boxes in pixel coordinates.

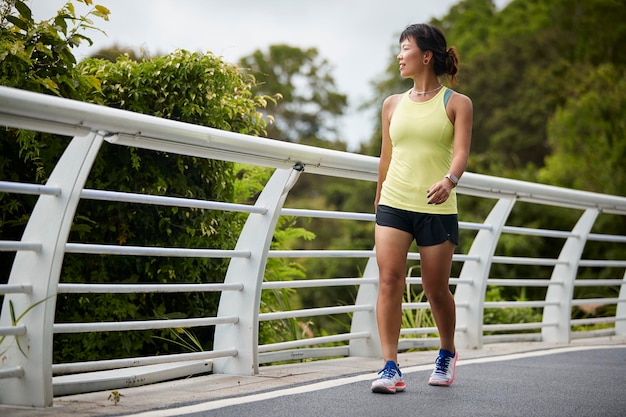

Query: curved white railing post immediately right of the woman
[454,198,516,349]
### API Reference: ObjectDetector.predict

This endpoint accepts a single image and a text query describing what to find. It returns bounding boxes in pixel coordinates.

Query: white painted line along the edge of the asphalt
[120,345,624,417]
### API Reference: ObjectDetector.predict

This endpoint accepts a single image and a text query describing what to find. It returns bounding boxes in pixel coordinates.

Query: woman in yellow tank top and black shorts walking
[372,24,473,393]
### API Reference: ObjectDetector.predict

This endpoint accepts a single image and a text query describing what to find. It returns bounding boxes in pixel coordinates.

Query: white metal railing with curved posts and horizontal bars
[0,87,626,407]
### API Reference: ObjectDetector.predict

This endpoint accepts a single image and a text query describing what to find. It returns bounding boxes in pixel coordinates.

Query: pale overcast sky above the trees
[28,0,510,150]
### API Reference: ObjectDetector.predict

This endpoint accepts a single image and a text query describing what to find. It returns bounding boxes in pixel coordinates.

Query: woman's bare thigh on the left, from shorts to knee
[375,224,413,278]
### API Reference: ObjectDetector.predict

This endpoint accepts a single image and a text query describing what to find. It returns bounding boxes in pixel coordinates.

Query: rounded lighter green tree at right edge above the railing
[539,64,626,195]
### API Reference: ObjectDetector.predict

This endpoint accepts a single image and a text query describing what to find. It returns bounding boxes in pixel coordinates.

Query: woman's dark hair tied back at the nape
[400,23,459,84]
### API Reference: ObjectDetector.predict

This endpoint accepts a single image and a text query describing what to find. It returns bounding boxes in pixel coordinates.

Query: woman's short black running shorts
[376,205,459,246]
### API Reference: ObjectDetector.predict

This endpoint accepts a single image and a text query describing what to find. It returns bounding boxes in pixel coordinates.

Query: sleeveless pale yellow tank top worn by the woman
[379,87,457,214]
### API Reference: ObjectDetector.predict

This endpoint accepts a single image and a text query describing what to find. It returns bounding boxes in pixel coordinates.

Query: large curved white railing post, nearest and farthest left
[0,133,103,407]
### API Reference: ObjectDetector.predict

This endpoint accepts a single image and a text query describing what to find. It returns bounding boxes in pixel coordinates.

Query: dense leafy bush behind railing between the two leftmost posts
[55,50,276,361]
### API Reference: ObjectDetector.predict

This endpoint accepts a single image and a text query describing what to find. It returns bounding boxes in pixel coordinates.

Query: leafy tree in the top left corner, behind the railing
[0,0,109,283]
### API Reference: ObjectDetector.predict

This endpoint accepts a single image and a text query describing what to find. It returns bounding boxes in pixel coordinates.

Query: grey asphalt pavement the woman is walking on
[160,347,626,417]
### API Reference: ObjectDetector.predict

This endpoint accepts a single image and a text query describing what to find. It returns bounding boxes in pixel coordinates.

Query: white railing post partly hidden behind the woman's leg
[350,252,383,358]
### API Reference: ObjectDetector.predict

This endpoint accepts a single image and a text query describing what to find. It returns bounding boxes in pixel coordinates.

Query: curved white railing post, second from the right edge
[541,209,599,343]
